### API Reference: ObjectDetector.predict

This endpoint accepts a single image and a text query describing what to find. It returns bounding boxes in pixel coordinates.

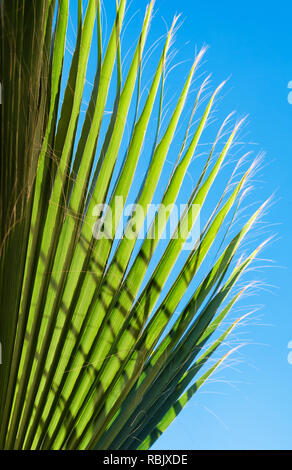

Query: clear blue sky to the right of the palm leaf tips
[69,0,292,449]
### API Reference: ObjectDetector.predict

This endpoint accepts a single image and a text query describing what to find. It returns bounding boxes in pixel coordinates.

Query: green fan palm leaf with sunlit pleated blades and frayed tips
[0,0,266,449]
